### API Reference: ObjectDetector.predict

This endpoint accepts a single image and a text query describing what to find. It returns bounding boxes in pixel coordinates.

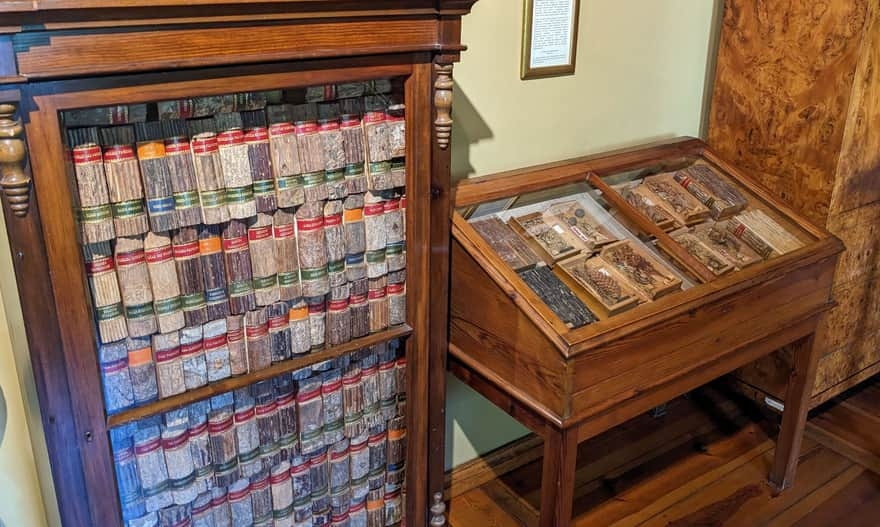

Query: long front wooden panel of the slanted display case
[572,258,834,418]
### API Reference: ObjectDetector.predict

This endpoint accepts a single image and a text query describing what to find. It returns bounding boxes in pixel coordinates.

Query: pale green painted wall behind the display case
[446,0,720,468]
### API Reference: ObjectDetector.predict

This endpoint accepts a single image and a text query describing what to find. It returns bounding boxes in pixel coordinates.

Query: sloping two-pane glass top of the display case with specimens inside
[454,142,822,336]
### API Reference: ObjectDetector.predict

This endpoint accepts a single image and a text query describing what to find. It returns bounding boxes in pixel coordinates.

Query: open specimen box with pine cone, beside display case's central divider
[600,240,681,300]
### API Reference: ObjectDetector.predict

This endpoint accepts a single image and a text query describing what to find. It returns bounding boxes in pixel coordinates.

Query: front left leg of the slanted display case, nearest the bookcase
[539,427,577,527]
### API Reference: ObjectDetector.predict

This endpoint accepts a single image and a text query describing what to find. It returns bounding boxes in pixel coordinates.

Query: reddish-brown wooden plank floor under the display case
[448,379,880,527]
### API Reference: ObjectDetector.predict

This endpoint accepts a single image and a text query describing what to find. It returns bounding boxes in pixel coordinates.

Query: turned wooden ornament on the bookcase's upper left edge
[0,102,31,217]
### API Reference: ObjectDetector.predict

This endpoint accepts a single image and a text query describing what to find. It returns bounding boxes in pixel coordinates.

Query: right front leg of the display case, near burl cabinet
[770,334,819,494]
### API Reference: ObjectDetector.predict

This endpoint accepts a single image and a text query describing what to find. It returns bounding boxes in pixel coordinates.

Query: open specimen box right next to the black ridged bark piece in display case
[558,256,640,316]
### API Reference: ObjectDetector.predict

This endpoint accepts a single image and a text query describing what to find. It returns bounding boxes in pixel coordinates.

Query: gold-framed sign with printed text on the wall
[520,0,580,80]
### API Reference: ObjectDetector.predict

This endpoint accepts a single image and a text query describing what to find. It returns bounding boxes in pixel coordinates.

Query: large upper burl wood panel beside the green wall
[709,0,868,225]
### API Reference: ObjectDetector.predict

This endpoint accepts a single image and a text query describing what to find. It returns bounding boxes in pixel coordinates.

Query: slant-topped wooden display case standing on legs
[449,138,842,527]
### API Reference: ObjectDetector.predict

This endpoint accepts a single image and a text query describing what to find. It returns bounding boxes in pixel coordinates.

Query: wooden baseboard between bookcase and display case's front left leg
[443,434,544,501]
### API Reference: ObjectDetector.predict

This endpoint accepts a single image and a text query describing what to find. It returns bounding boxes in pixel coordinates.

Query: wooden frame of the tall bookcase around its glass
[0,0,475,526]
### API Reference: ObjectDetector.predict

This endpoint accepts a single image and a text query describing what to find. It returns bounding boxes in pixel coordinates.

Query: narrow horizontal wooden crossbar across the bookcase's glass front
[107,324,413,428]
